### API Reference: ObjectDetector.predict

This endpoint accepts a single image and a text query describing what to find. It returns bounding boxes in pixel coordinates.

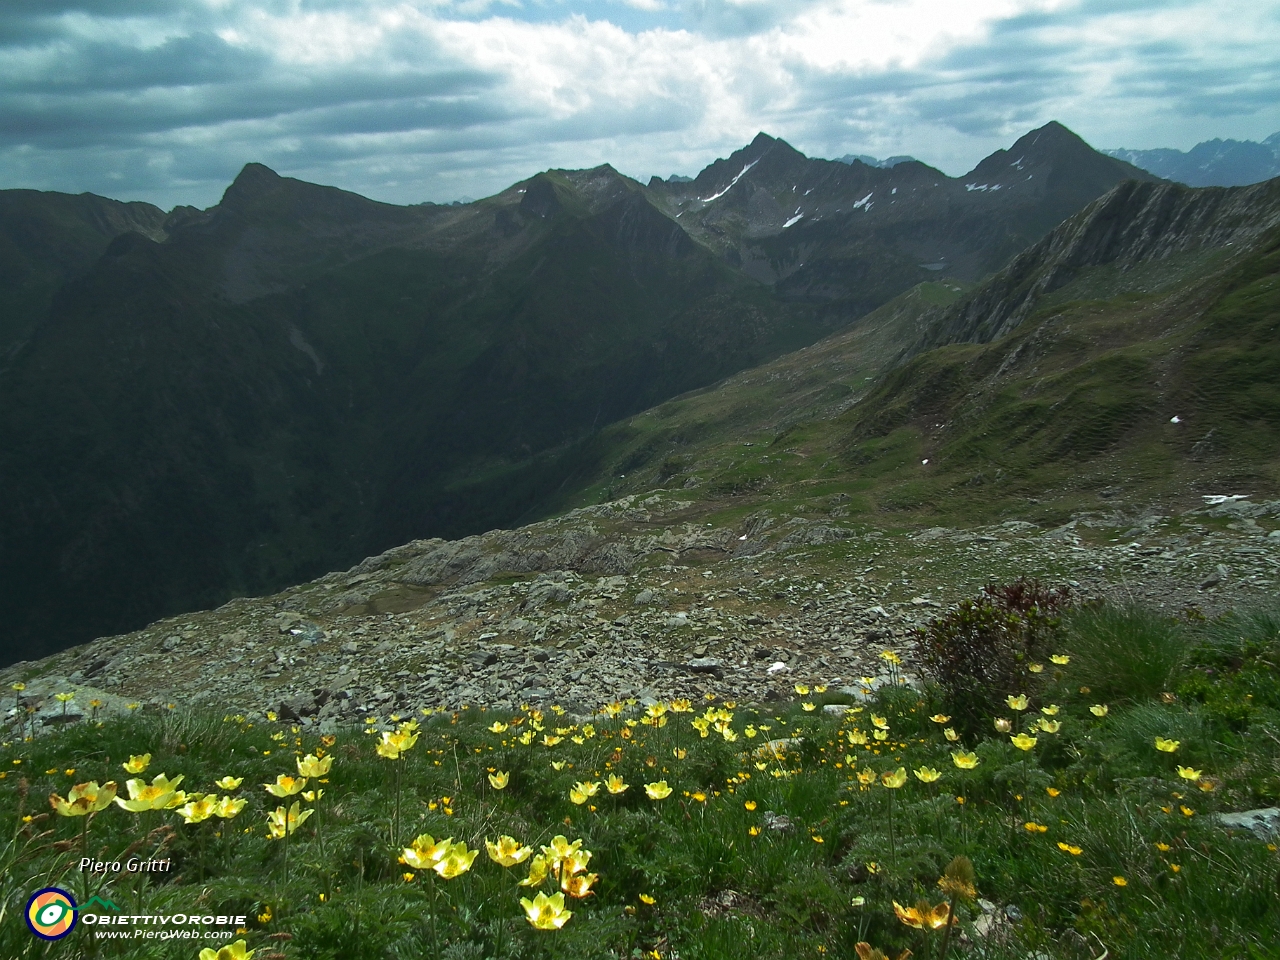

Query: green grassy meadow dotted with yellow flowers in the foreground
[0,601,1280,960]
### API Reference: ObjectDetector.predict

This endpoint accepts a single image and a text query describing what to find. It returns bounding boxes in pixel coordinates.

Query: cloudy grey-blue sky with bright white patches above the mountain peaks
[0,0,1280,207]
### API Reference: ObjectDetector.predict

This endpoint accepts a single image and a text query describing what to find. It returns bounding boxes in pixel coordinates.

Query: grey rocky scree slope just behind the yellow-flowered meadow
[0,494,1280,727]
